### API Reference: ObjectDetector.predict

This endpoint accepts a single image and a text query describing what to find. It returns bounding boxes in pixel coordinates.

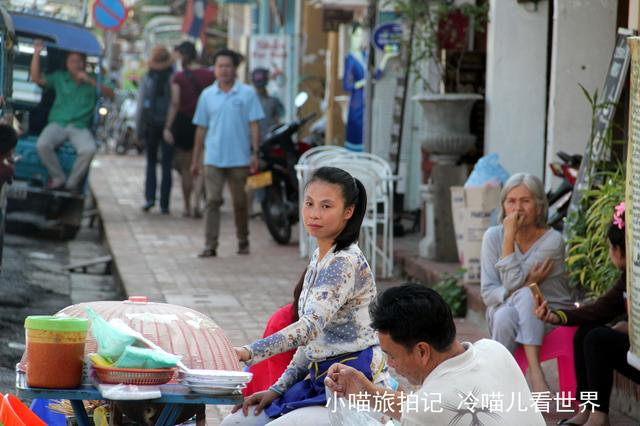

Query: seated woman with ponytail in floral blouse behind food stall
[222,167,388,426]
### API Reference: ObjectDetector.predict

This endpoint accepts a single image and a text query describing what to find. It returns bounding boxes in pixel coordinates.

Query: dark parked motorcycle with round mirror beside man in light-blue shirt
[260,93,315,244]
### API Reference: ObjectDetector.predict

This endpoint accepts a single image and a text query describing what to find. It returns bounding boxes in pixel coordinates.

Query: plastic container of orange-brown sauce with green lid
[24,316,89,389]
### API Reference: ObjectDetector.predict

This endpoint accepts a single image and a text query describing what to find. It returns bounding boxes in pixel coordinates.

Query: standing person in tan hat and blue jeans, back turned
[136,45,173,214]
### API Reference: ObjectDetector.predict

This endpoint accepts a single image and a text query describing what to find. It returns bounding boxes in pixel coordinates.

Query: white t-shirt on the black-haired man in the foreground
[401,339,545,426]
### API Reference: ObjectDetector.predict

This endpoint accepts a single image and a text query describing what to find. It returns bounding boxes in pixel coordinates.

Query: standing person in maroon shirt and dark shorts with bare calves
[163,41,215,218]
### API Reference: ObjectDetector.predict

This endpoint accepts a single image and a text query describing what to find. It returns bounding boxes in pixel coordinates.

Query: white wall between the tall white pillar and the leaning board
[545,0,617,186]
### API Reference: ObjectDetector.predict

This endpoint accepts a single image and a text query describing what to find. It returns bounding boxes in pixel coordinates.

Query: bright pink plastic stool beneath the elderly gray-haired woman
[513,327,578,397]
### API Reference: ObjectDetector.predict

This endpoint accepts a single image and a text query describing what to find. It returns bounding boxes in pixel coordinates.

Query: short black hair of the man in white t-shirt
[369,283,456,352]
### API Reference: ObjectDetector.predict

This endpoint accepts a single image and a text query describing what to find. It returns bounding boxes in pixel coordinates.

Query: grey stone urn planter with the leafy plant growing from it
[388,0,489,160]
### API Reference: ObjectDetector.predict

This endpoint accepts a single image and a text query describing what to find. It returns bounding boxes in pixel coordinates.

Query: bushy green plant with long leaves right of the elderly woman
[565,86,625,298]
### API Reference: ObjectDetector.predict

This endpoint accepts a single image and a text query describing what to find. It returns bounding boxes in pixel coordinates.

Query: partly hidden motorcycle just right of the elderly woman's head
[547,151,582,230]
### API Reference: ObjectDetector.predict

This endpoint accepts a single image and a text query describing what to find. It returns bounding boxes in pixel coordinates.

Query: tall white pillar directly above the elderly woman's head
[485,0,552,177]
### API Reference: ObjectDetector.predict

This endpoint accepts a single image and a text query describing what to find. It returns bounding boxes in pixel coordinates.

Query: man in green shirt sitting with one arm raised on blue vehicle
[30,39,113,192]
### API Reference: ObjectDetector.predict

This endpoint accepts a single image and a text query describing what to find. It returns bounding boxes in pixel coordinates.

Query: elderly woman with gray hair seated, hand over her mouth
[480,173,573,392]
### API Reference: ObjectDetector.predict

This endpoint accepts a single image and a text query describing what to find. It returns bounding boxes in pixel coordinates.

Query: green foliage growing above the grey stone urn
[385,0,489,93]
